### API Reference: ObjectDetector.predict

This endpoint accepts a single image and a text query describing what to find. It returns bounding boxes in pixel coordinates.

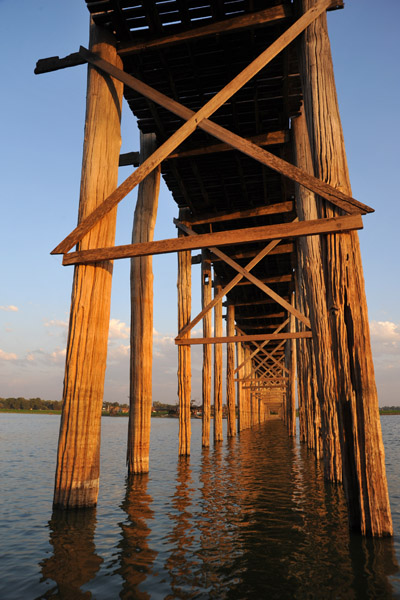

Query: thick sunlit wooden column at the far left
[54,24,123,508]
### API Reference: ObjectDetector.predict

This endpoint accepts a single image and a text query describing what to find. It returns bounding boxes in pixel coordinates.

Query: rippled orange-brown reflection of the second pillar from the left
[119,474,157,600]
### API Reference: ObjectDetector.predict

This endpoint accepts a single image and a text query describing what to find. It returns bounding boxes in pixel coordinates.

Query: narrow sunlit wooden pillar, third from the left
[177,215,192,455]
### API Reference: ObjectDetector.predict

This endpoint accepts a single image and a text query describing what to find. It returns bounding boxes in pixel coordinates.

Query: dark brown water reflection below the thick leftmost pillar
[41,509,103,600]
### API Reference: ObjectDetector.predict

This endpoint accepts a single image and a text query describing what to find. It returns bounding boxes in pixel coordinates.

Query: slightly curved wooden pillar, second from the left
[127,133,160,473]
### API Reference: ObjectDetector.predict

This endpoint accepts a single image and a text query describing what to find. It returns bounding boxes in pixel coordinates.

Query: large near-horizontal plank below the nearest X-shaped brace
[63,213,363,265]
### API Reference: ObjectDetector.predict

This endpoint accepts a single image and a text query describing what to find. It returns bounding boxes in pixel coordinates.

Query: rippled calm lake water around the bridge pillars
[0,414,400,600]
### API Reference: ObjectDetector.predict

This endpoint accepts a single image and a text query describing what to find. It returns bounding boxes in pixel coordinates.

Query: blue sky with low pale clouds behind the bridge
[0,0,400,405]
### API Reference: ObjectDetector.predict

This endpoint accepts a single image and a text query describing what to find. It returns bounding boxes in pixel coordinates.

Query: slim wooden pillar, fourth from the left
[201,250,212,448]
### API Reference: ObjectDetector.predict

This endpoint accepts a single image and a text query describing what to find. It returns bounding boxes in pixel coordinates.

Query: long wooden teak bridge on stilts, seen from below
[35,0,392,536]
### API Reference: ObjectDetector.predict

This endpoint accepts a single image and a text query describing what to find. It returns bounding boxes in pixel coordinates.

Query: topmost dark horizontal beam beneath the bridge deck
[118,4,292,56]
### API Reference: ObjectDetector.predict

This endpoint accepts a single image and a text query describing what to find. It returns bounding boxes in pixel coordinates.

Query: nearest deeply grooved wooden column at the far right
[301,0,393,535]
